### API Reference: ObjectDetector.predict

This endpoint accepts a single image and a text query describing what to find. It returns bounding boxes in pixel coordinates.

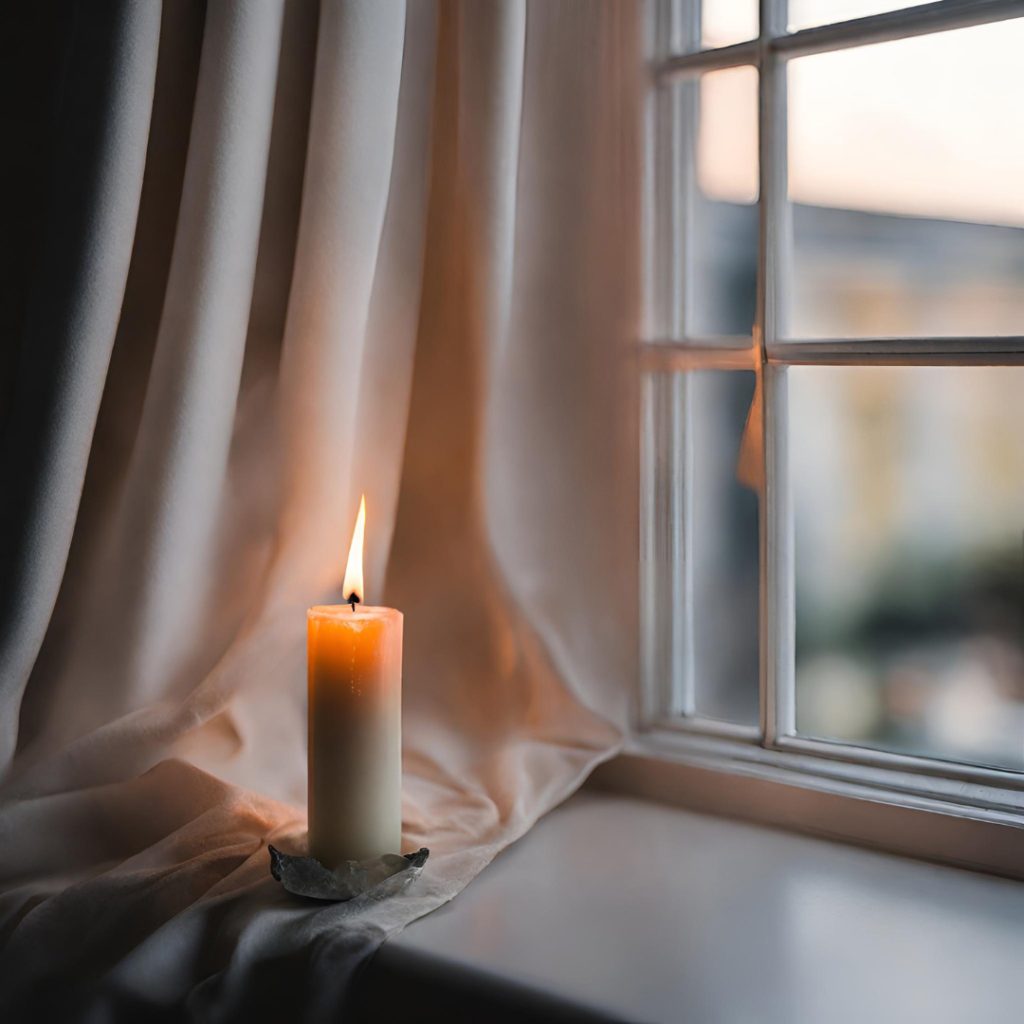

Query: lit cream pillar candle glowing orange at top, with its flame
[306,497,401,867]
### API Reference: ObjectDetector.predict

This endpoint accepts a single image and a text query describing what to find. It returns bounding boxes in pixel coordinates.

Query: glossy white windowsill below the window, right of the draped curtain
[359,792,1024,1024]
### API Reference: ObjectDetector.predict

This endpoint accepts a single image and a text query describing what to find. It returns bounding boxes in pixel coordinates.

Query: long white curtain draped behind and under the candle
[0,0,639,1020]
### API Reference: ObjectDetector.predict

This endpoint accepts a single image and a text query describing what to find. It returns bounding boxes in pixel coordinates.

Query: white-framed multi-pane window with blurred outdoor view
[641,0,1024,864]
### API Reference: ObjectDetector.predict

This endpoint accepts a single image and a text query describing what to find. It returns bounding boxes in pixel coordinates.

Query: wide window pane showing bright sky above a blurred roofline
[788,18,1024,338]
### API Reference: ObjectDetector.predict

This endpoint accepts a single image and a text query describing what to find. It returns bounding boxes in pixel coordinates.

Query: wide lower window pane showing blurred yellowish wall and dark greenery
[788,367,1024,769]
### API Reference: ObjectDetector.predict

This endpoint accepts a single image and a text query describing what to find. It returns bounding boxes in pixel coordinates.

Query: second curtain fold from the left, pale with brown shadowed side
[41,2,283,753]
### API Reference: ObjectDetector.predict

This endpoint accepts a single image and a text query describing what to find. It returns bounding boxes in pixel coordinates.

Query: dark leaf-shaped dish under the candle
[269,846,430,902]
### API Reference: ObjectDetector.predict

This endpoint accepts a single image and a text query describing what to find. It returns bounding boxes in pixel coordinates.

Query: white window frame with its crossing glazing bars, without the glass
[642,0,1024,790]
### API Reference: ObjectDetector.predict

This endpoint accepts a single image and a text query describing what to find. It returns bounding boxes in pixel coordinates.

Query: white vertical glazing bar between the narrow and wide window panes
[755,0,794,746]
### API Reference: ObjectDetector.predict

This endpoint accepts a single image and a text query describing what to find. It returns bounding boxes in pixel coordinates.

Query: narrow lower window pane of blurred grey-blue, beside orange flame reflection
[687,371,758,725]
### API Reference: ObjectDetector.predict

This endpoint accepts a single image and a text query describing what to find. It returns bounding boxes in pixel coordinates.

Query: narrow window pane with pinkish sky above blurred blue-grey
[684,68,758,336]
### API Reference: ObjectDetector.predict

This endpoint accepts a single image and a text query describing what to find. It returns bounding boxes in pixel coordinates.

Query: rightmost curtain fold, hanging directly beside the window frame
[482,0,640,722]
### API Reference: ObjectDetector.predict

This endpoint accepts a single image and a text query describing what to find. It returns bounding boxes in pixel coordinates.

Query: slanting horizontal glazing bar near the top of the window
[653,0,1024,79]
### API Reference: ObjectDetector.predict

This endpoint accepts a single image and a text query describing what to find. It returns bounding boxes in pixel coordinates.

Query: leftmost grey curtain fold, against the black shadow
[0,2,160,771]
